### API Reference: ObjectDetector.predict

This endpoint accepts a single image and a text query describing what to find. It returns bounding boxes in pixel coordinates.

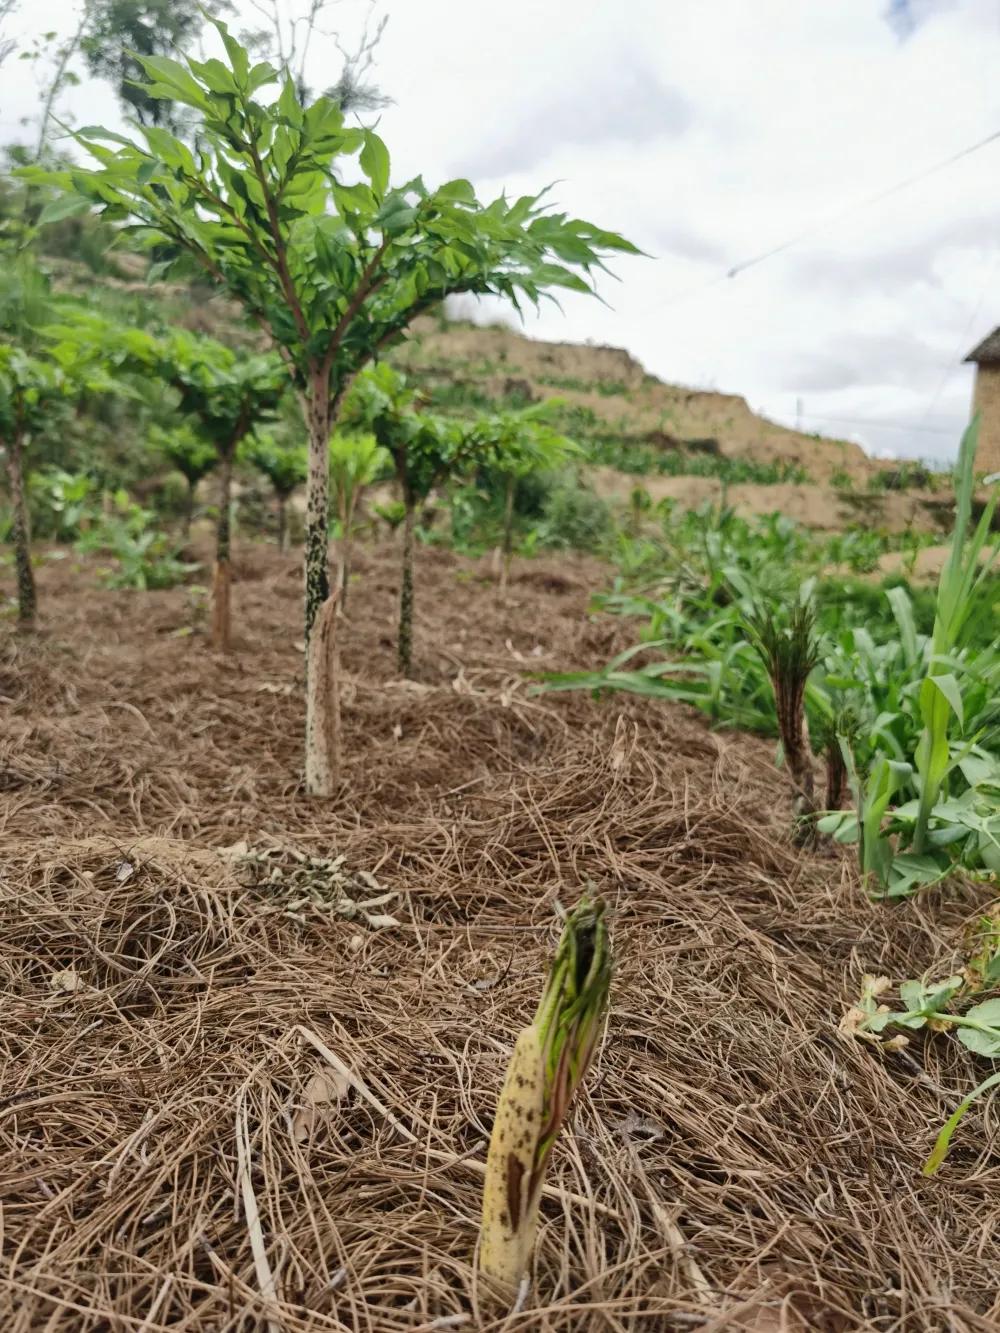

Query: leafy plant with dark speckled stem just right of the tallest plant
[345,364,483,676]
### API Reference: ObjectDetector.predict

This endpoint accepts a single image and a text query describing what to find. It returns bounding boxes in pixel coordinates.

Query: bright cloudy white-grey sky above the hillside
[0,0,1000,459]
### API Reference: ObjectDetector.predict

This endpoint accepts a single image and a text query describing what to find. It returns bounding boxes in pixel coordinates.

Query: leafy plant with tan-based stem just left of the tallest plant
[120,329,288,652]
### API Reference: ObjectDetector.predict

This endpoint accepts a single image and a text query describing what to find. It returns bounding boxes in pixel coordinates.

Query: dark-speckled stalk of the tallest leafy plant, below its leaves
[305,372,339,796]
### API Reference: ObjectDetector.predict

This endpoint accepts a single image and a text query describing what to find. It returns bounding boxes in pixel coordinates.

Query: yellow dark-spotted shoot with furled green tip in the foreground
[479,898,611,1293]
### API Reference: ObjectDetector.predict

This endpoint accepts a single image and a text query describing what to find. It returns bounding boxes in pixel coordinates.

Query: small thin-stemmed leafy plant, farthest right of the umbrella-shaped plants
[473,399,580,597]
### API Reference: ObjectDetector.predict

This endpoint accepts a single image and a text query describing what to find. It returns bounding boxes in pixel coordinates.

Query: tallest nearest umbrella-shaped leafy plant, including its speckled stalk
[35,21,635,794]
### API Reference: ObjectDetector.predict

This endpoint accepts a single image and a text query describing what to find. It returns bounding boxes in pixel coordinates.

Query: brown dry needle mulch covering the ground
[0,548,1000,1333]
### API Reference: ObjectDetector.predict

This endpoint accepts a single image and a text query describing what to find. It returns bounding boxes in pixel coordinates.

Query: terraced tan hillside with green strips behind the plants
[52,255,965,531]
